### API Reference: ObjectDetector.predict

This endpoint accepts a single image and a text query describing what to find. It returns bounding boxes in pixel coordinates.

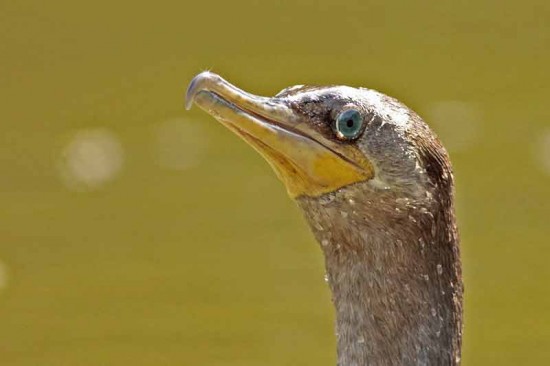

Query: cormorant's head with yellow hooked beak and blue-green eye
[186,72,446,198]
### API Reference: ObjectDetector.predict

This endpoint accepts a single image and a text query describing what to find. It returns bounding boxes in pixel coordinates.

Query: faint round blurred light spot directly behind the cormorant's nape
[426,100,482,152]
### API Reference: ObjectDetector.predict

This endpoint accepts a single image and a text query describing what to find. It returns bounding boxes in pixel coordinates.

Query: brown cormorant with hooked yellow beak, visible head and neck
[186,72,463,366]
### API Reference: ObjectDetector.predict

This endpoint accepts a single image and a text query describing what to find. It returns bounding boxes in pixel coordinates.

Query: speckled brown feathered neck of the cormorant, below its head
[298,186,462,366]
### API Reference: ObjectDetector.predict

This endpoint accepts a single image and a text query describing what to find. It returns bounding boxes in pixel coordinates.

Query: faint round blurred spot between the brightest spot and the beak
[156,118,208,170]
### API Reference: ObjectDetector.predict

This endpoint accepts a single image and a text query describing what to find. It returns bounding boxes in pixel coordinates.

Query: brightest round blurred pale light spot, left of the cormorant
[58,128,124,191]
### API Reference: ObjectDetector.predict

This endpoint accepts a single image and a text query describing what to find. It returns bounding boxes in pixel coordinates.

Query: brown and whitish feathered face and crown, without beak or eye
[277,86,440,194]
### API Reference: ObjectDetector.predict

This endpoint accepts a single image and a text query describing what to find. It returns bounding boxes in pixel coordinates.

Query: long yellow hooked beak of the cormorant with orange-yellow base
[186,72,373,198]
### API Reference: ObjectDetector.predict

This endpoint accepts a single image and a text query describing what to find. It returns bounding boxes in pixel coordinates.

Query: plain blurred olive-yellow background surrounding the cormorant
[0,0,550,366]
